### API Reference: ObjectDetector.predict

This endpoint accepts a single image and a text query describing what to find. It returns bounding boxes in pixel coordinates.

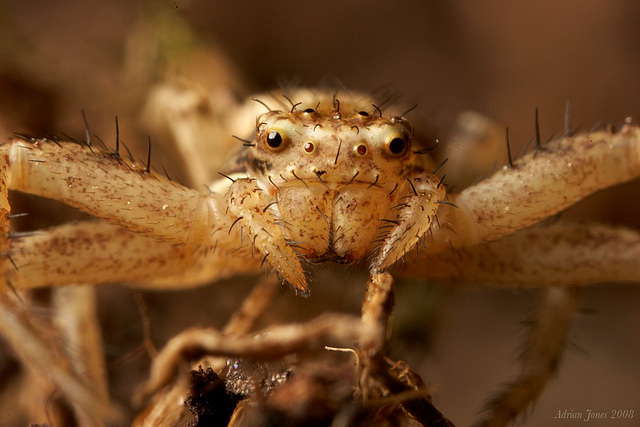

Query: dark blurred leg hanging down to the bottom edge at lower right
[477,288,579,427]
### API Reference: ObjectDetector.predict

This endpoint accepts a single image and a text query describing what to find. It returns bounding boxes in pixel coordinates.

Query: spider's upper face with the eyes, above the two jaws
[252,106,415,190]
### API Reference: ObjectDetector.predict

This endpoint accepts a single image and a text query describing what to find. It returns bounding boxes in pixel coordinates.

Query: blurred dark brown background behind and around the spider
[0,0,640,426]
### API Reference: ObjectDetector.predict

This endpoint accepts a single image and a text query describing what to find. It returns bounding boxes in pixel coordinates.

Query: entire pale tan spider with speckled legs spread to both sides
[0,90,640,425]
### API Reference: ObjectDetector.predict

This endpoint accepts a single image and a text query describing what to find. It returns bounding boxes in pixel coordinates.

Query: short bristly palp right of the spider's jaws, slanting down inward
[371,172,446,272]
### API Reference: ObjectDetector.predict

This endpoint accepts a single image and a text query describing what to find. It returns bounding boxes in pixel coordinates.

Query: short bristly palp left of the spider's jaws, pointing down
[227,178,308,295]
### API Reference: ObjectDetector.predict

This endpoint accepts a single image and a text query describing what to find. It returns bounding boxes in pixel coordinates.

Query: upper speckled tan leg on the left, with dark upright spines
[0,140,223,244]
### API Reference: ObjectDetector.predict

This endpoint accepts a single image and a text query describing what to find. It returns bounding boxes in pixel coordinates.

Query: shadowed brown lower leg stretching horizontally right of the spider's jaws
[398,222,640,287]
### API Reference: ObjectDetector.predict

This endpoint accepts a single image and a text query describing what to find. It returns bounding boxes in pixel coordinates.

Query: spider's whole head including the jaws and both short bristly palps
[221,93,445,290]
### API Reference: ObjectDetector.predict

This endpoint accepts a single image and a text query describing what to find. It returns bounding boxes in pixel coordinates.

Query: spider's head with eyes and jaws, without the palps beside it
[246,94,438,263]
